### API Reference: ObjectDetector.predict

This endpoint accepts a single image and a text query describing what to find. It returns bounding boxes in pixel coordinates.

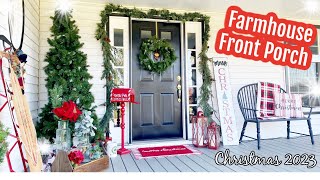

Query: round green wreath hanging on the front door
[139,37,177,74]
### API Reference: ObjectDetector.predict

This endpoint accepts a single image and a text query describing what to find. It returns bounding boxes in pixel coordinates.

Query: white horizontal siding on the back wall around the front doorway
[39,0,320,145]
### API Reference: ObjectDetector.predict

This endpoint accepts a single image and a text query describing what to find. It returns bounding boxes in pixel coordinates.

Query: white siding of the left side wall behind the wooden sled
[0,0,40,172]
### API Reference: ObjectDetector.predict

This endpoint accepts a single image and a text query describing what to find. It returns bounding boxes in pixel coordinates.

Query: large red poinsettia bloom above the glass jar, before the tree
[53,101,82,122]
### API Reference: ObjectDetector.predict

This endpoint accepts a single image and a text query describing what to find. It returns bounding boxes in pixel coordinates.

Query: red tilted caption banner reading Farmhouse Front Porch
[215,6,317,70]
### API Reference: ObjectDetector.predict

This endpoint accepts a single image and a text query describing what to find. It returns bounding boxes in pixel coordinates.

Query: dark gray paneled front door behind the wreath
[132,21,182,140]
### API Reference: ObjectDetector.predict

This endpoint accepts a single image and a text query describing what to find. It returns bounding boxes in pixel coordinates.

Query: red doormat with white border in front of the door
[132,145,202,159]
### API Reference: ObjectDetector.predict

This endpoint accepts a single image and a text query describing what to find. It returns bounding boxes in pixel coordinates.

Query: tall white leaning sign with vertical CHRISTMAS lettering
[213,58,239,145]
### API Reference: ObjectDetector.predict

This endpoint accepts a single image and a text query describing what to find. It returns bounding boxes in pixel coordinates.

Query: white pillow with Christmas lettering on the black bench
[274,93,304,118]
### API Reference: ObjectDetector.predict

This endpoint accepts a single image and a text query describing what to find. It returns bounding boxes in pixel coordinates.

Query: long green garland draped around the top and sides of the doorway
[96,4,214,128]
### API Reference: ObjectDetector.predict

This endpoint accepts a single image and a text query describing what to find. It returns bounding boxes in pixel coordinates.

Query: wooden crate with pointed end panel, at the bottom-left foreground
[51,151,109,172]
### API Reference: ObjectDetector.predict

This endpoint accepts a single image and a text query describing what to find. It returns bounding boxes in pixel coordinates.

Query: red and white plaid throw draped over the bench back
[257,82,280,117]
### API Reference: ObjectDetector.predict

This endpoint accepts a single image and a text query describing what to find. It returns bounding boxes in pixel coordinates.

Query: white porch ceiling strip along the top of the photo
[107,0,320,20]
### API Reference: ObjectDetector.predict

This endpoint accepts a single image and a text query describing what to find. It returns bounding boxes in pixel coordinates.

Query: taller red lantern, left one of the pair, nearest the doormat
[192,111,208,147]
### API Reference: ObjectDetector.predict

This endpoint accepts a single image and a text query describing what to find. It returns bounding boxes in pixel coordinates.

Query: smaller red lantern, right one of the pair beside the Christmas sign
[207,122,220,150]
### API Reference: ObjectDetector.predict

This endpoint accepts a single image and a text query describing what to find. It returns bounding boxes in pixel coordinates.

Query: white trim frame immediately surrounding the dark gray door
[127,17,188,144]
